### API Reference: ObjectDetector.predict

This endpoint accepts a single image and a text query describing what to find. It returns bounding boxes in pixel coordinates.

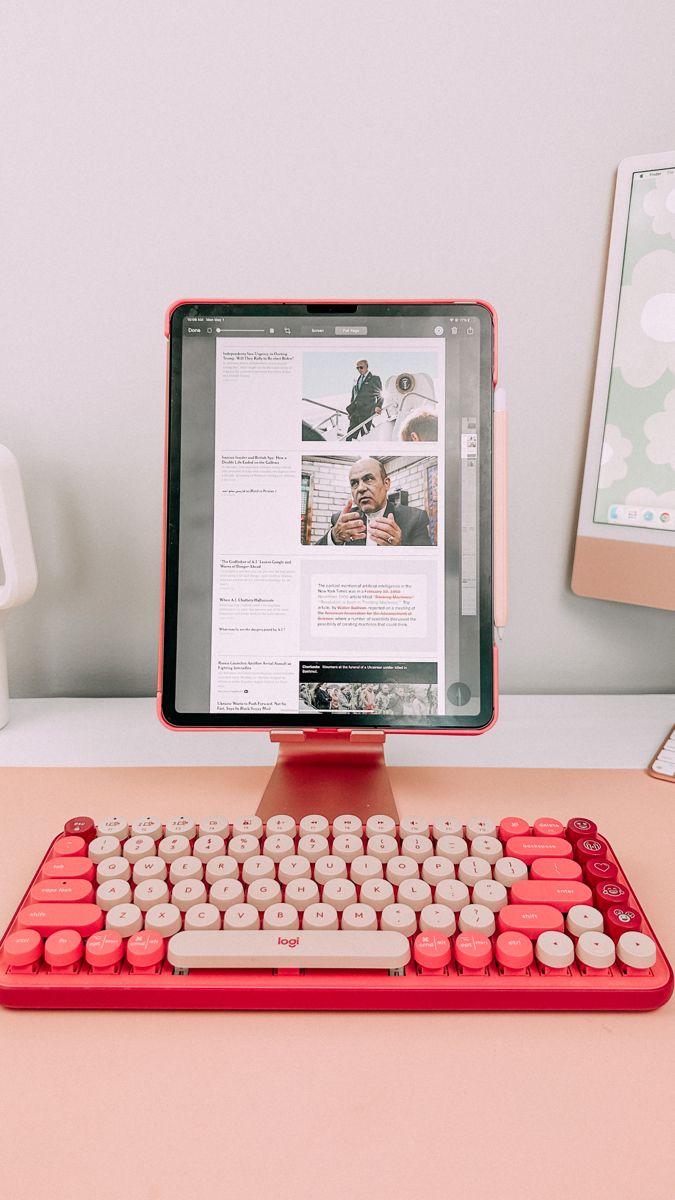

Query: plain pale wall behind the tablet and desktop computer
[0,0,675,696]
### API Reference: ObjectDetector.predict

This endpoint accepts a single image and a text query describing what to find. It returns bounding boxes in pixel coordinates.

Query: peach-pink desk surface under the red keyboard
[0,768,675,1200]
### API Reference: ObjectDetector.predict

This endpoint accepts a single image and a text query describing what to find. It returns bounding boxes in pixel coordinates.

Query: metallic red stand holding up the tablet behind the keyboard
[257,730,399,823]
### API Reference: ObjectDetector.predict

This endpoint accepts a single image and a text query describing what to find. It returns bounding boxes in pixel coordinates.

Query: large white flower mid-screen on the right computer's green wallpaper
[614,250,675,388]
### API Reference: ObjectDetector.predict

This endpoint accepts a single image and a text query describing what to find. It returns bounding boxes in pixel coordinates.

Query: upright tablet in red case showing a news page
[159,300,496,732]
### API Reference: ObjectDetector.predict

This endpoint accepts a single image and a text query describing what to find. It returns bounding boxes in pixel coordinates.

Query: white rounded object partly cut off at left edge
[0,445,37,730]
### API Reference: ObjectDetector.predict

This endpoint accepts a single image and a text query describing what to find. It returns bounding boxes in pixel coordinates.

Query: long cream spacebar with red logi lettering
[167,929,410,971]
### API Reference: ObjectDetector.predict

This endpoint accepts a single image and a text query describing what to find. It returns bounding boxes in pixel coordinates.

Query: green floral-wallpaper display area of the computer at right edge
[593,164,675,530]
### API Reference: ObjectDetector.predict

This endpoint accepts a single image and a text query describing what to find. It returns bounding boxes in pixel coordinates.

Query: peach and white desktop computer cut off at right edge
[572,151,675,608]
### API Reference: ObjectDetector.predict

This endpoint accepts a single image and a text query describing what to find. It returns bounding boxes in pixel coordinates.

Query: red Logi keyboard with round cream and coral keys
[0,814,673,1009]
